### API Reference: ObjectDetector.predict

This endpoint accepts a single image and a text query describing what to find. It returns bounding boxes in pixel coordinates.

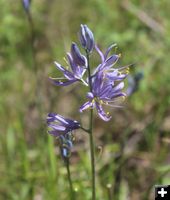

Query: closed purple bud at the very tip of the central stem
[79,24,94,53]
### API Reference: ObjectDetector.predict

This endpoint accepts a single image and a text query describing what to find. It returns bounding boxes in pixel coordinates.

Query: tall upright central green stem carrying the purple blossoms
[86,51,96,200]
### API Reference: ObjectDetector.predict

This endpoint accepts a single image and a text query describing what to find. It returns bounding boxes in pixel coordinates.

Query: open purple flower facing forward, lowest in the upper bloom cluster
[80,71,126,121]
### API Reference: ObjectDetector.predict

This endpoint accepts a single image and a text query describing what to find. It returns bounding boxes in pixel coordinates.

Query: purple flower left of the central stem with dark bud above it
[50,43,87,86]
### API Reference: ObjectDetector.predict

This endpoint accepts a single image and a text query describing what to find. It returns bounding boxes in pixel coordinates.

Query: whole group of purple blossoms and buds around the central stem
[47,25,129,157]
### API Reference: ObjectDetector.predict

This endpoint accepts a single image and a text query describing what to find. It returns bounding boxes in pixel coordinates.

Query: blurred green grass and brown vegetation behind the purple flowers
[0,0,170,200]
